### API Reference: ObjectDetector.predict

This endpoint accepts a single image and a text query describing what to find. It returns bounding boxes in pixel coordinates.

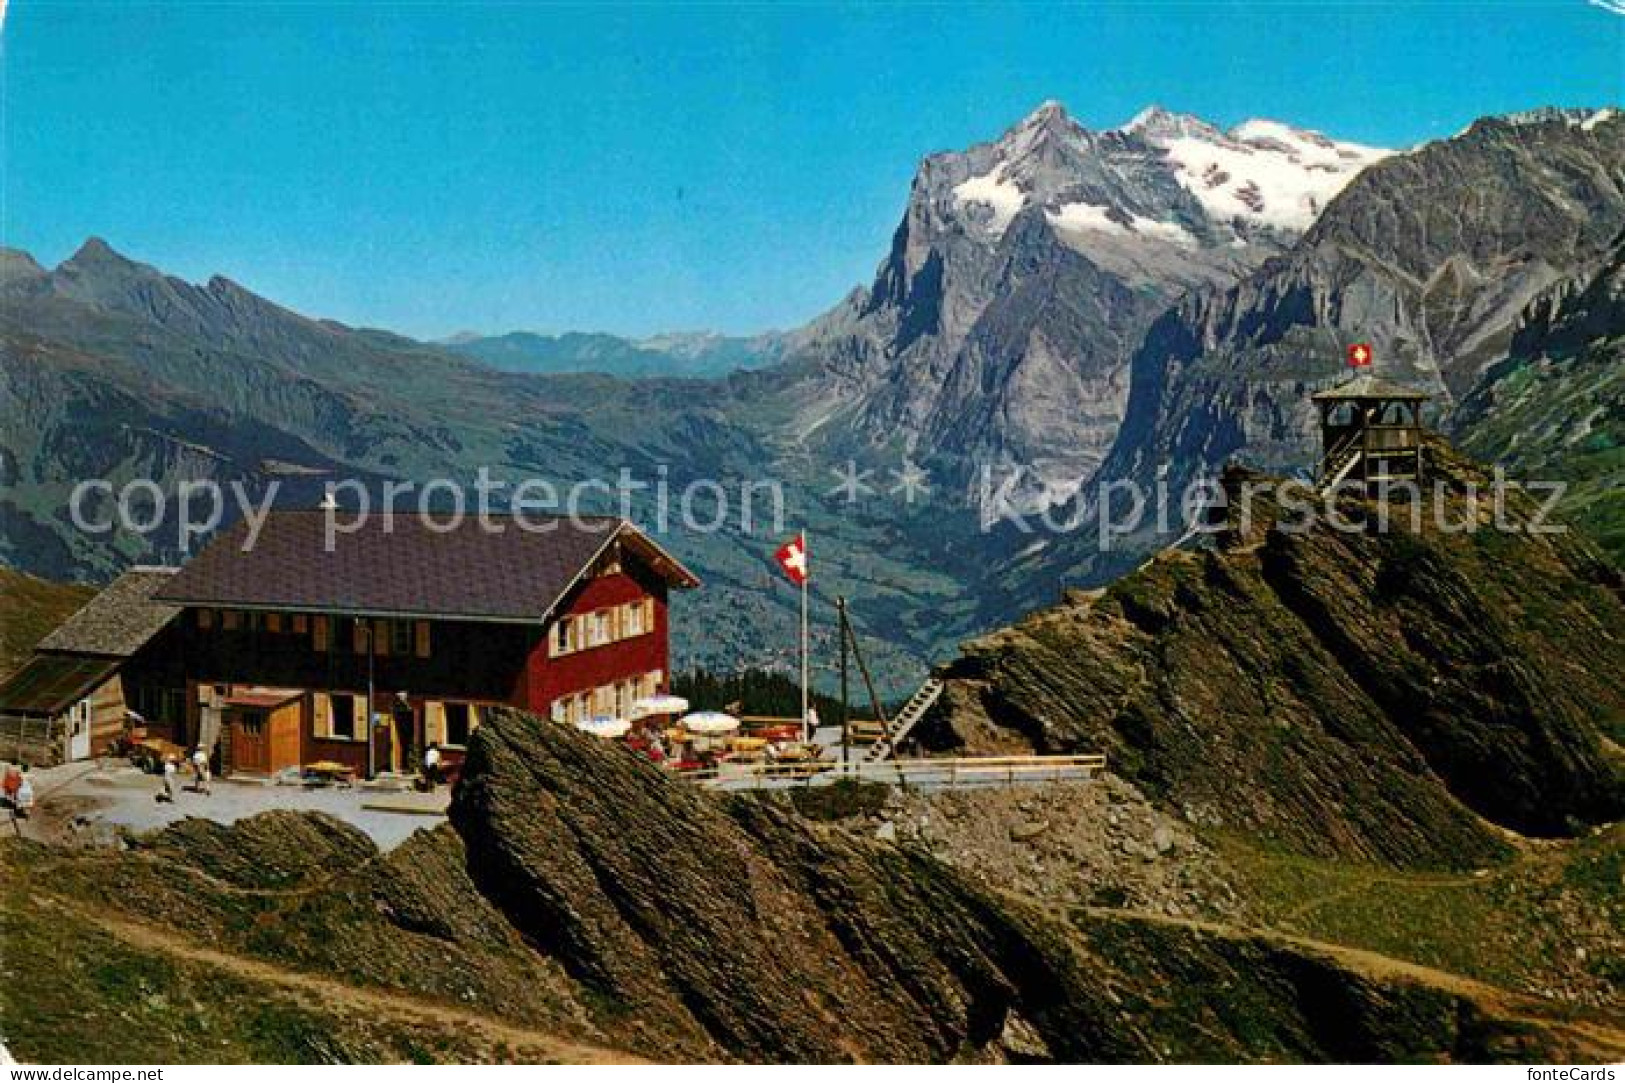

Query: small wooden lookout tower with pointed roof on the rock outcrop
[1310,376,1430,488]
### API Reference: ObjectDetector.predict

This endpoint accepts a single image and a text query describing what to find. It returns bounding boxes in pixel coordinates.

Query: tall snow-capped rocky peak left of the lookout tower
[793,102,1385,504]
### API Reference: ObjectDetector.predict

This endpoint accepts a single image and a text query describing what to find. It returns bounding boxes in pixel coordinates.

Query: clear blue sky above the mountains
[0,0,1625,337]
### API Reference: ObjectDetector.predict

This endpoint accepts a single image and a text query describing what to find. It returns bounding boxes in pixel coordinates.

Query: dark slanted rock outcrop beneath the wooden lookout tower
[921,444,1625,867]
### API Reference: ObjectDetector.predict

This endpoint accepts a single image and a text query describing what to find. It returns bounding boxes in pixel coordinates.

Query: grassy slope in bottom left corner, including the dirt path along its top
[0,880,643,1063]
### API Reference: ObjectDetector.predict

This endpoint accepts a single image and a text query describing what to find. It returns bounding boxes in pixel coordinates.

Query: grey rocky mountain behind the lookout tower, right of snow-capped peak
[1100,109,1625,500]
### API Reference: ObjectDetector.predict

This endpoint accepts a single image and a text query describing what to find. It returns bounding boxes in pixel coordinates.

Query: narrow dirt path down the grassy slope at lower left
[29,896,644,1063]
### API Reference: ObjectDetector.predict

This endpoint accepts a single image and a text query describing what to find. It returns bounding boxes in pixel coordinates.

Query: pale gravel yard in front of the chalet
[7,761,450,850]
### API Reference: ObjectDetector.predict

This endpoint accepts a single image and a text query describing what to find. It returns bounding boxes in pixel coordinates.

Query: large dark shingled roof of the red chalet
[159,511,699,621]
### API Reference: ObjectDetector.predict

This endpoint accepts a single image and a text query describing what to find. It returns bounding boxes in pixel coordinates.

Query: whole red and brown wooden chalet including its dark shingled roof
[0,511,699,774]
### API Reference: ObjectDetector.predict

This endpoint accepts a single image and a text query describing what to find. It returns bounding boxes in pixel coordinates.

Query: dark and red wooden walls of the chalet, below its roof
[124,523,694,774]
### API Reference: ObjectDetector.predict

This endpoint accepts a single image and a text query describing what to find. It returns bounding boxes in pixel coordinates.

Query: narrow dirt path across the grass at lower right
[1066,906,1625,1062]
